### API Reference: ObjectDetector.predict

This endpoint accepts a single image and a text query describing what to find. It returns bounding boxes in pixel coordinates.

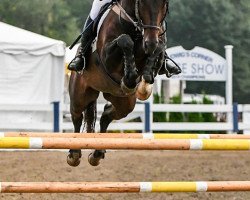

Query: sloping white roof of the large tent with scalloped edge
[0,22,65,56]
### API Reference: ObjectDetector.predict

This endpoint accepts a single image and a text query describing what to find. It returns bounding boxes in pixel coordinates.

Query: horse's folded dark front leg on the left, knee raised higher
[105,34,139,94]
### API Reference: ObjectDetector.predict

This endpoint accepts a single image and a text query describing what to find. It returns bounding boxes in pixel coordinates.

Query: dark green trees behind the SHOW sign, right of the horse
[168,0,250,103]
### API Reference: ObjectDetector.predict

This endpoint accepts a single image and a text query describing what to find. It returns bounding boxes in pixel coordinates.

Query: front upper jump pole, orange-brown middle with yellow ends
[0,137,250,150]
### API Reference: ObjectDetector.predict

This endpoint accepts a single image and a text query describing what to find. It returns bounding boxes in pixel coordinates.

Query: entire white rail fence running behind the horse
[0,104,250,133]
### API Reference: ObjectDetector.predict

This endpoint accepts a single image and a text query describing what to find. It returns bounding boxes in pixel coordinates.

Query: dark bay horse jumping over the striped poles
[67,0,168,166]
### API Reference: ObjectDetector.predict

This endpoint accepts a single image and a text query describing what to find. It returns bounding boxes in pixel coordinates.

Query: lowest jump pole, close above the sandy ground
[0,181,250,193]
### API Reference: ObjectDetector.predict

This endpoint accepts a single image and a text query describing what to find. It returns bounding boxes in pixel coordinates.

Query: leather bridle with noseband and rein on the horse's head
[115,0,167,35]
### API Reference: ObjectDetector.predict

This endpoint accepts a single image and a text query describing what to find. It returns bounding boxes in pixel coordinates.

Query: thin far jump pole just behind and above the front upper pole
[0,132,250,139]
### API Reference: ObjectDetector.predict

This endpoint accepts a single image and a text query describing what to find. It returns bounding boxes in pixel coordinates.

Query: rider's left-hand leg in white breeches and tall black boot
[68,0,112,71]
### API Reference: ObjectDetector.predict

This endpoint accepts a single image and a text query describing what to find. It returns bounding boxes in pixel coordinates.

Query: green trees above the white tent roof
[0,0,79,43]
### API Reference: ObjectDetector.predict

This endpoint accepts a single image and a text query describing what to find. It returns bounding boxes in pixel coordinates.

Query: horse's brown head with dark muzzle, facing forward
[135,0,169,54]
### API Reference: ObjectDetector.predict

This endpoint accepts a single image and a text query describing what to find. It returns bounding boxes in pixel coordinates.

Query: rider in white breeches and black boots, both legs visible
[68,0,181,77]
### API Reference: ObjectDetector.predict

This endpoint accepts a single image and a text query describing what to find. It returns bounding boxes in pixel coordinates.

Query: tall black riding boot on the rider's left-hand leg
[68,17,95,71]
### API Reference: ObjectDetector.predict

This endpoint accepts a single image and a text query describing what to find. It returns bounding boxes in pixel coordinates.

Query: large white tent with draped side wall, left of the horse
[0,22,65,104]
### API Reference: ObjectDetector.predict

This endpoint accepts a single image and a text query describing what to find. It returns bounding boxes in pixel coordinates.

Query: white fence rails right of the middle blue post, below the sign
[149,104,250,132]
